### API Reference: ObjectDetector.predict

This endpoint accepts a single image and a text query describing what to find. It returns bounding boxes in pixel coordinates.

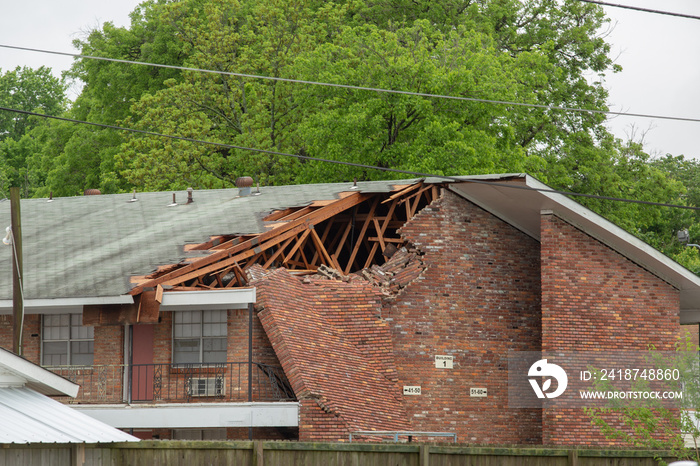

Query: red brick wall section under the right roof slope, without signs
[541,215,680,445]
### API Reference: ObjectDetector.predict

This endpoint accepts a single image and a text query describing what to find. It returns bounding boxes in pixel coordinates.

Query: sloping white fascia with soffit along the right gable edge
[526,175,700,290]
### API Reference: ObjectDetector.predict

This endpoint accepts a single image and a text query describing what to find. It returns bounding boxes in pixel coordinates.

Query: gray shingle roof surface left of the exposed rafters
[0,180,422,300]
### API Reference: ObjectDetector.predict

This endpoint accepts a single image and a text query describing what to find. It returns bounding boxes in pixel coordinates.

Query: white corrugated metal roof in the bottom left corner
[0,387,139,444]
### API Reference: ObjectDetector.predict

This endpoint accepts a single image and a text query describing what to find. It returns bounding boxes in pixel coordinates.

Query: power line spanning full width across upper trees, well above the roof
[0,44,700,123]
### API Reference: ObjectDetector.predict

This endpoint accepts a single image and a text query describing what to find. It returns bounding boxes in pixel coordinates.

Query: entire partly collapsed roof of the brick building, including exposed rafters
[0,174,700,320]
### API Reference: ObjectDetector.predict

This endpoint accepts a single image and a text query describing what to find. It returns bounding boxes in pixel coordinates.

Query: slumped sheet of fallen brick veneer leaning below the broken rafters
[255,269,409,441]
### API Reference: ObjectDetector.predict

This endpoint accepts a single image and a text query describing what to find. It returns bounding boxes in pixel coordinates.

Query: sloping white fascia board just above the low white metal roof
[0,350,80,398]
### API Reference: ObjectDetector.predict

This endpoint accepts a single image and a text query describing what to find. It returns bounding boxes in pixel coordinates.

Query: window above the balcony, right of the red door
[173,311,227,364]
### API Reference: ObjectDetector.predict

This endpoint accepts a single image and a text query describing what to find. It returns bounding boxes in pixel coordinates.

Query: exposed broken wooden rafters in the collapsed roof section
[131,182,439,295]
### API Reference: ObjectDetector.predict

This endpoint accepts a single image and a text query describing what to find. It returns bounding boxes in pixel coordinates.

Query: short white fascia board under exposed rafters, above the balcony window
[160,287,256,311]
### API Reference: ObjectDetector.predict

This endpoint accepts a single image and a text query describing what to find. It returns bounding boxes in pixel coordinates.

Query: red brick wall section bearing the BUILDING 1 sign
[383,191,541,444]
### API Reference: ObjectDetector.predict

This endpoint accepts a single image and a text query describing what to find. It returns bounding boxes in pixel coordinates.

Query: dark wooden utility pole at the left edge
[10,188,24,356]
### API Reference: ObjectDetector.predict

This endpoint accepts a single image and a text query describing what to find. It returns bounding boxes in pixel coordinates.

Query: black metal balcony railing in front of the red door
[47,362,296,403]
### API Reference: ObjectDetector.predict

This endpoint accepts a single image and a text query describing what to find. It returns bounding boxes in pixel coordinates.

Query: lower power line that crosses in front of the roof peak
[0,107,700,210]
